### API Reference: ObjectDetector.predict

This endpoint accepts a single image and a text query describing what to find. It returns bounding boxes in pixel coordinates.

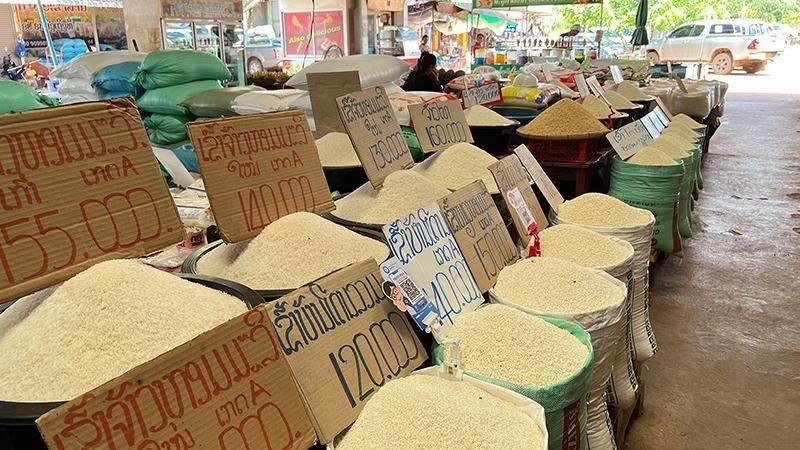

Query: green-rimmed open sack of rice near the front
[431,305,594,450]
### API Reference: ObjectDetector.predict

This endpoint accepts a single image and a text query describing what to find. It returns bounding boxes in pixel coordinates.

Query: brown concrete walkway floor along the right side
[626,72,800,450]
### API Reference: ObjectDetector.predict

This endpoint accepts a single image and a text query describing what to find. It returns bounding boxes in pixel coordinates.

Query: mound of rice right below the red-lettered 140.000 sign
[197,212,389,290]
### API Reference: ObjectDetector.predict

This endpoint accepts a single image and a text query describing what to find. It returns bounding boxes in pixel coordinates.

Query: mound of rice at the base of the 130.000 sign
[331,170,450,225]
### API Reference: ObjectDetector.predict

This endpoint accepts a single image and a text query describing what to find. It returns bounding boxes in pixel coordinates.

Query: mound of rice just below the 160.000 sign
[414,143,499,192]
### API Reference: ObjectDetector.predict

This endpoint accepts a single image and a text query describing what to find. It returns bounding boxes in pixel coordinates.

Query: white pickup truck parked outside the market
[646,20,780,75]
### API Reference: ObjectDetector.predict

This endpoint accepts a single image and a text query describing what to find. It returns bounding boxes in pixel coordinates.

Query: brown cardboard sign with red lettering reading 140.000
[187,110,334,242]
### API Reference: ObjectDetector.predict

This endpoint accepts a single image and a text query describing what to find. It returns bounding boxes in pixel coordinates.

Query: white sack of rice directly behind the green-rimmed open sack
[489,257,628,450]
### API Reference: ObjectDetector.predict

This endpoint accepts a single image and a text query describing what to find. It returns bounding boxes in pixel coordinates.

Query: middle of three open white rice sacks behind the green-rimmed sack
[539,224,639,408]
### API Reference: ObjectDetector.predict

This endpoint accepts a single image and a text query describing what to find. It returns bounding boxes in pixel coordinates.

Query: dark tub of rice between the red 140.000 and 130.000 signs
[316,132,367,193]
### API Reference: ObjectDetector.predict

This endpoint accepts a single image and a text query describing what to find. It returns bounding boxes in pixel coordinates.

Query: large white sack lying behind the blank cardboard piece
[286,55,411,91]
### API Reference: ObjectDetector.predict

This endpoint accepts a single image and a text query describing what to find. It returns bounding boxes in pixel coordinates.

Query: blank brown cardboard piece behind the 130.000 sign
[306,71,361,136]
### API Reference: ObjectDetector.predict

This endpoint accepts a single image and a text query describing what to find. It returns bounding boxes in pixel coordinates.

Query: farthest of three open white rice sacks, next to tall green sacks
[549,193,658,362]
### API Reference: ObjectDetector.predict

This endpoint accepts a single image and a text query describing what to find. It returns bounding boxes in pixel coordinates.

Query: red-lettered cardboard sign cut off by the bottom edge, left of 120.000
[36,305,316,450]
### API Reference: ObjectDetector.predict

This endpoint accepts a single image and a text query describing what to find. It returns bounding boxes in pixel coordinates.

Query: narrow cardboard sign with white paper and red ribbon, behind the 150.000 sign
[489,155,547,247]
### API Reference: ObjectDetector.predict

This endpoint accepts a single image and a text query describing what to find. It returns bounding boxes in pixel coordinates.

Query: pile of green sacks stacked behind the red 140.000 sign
[133,50,231,145]
